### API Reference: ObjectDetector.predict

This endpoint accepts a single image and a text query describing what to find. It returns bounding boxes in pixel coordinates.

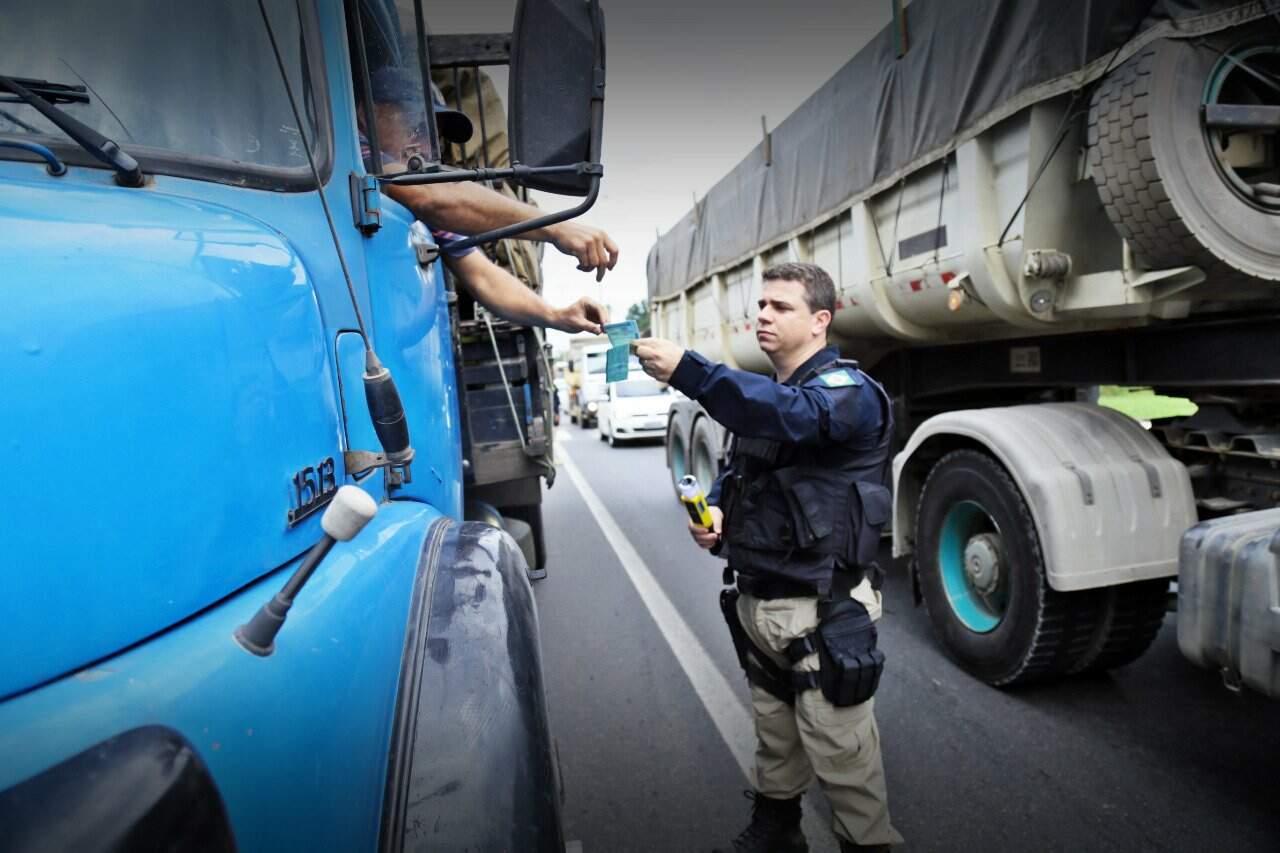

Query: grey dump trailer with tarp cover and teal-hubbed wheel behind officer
[648,0,1280,697]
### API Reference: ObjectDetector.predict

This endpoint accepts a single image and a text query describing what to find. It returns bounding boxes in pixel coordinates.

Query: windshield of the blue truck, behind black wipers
[0,0,325,186]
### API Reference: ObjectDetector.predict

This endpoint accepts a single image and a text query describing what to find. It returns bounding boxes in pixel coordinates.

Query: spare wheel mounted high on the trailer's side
[1089,33,1280,279]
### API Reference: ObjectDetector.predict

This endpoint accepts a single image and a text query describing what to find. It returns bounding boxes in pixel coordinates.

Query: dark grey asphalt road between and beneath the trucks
[535,425,1280,853]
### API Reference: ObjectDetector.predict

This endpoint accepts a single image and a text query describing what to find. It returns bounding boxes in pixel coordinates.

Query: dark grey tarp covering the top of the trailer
[648,0,1280,298]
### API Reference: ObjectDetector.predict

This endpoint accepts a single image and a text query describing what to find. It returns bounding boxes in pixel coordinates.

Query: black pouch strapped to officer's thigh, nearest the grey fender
[806,598,884,708]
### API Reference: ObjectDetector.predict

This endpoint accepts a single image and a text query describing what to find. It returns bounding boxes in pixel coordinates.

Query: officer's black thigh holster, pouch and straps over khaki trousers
[721,573,884,708]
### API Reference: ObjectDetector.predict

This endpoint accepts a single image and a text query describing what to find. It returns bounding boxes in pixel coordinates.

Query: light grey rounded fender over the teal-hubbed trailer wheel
[893,403,1197,592]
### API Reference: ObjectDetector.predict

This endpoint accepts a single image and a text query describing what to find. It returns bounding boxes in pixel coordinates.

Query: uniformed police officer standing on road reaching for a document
[635,264,902,853]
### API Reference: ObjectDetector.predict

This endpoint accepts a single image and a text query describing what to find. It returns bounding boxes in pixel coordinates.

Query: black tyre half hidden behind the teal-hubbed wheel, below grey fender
[1073,578,1169,672]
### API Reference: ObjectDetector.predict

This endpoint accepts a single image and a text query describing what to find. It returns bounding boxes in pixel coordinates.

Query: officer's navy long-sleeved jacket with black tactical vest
[671,347,890,594]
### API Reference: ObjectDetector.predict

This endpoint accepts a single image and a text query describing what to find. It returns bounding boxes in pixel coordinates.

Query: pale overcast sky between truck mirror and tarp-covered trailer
[424,0,890,345]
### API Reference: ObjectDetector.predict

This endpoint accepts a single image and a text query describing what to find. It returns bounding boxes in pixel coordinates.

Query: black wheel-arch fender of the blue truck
[380,519,564,853]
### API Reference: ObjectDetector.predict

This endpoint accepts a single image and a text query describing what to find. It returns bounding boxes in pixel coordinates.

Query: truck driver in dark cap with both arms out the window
[357,65,618,334]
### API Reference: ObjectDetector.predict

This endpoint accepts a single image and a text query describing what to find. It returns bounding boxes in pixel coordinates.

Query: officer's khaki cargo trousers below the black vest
[737,580,902,844]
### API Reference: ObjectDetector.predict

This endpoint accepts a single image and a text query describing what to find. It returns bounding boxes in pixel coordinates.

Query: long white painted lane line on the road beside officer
[557,448,838,853]
